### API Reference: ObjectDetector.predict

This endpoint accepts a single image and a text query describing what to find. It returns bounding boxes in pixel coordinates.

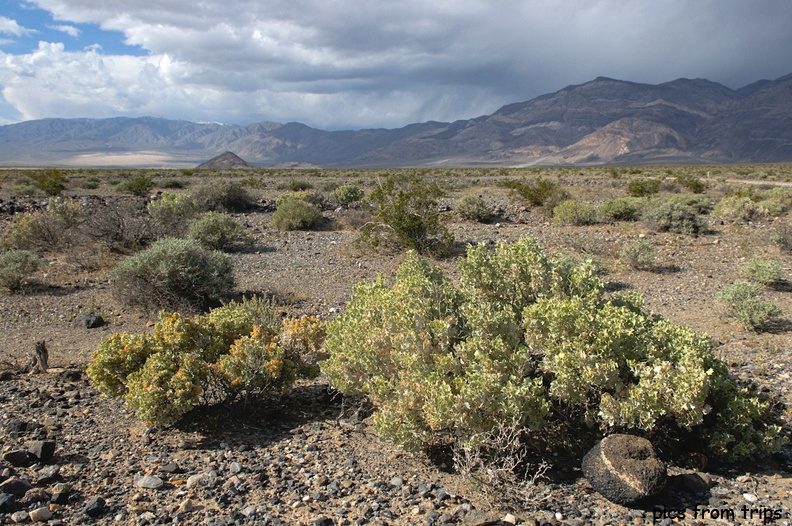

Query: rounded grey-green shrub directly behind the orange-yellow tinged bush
[110,238,234,308]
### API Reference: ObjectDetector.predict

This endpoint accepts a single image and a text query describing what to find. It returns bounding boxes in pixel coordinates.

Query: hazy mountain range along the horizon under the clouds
[0,74,792,167]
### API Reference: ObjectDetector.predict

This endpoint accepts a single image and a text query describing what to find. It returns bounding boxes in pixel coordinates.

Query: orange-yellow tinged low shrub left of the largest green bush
[87,299,321,425]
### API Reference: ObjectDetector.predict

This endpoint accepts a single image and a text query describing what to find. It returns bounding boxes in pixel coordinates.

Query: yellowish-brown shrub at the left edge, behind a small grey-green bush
[3,198,86,252]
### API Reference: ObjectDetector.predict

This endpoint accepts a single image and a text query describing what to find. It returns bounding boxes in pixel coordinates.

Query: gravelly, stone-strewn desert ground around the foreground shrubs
[0,171,792,526]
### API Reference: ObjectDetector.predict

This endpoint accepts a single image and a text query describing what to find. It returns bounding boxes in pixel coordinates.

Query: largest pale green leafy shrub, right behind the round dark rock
[322,238,783,464]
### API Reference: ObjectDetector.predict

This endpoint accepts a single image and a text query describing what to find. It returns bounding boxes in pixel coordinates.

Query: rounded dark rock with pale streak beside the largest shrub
[583,435,667,506]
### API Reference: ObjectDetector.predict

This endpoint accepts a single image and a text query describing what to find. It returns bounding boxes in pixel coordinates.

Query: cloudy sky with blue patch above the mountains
[0,0,792,130]
